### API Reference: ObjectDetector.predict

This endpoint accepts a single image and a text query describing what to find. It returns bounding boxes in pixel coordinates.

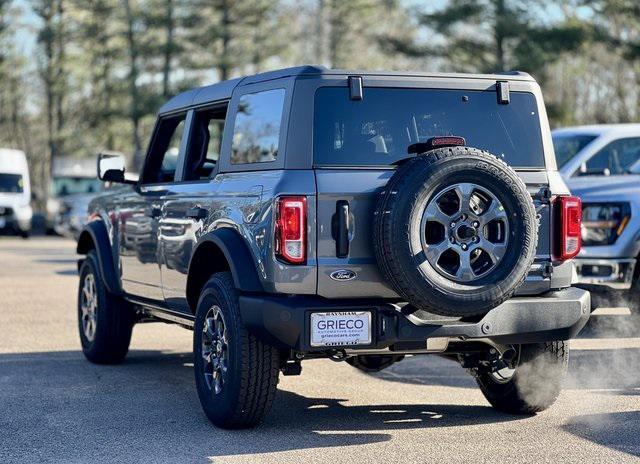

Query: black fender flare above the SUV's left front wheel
[76,220,122,295]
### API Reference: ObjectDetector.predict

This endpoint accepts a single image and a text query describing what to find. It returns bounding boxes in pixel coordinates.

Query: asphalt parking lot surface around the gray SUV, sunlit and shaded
[0,237,640,463]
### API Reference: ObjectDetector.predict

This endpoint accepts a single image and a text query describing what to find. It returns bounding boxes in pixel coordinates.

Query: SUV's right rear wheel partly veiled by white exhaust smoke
[476,341,569,414]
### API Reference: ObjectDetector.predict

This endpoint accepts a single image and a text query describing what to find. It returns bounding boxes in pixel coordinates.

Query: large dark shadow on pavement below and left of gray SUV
[0,351,518,463]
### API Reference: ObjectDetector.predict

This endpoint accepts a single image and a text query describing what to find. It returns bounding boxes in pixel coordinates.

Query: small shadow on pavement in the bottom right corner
[562,411,640,457]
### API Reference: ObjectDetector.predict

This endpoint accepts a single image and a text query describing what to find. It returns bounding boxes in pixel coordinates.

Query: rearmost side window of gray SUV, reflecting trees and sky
[231,89,285,164]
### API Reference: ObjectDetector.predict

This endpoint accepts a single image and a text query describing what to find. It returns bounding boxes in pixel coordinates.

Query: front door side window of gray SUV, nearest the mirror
[142,115,185,184]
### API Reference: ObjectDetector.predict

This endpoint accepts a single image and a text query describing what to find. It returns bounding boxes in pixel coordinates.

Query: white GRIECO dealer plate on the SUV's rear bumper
[311,311,371,346]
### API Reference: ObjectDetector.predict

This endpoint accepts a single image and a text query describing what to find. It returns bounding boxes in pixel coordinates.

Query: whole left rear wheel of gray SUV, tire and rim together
[193,272,280,428]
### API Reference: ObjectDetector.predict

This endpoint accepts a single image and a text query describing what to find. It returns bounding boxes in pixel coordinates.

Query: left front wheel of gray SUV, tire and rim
[78,251,134,364]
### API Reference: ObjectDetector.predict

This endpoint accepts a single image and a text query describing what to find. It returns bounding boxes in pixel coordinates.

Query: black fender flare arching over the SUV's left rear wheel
[187,227,263,292]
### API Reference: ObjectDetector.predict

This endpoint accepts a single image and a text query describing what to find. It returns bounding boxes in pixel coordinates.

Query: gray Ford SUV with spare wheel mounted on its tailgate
[77,66,590,428]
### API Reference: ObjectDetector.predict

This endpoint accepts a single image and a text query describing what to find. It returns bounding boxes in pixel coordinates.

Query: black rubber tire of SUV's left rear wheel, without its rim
[193,272,280,429]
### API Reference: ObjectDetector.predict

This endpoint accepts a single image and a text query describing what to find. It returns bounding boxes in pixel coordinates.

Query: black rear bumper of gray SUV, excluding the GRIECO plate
[240,287,590,352]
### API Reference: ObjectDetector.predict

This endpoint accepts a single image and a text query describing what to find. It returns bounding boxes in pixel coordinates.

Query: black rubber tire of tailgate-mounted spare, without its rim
[373,147,538,317]
